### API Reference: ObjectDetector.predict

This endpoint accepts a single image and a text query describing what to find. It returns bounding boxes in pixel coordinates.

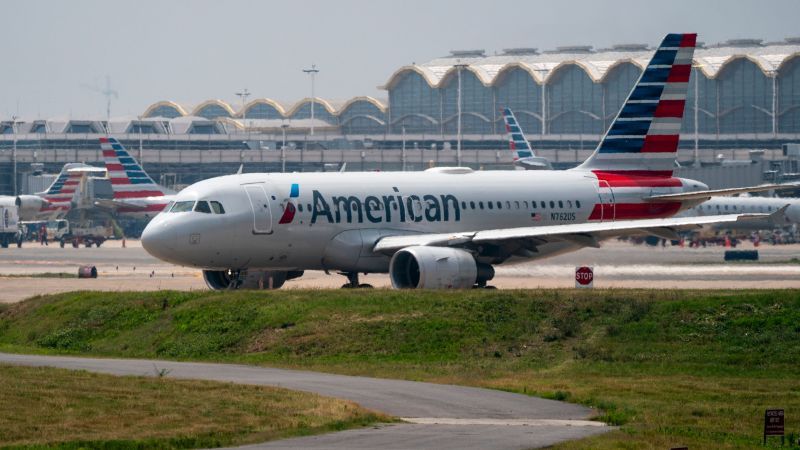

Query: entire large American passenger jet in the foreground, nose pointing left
[142,34,788,289]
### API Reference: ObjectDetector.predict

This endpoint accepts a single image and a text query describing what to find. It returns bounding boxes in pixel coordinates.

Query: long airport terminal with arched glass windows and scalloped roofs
[0,37,800,193]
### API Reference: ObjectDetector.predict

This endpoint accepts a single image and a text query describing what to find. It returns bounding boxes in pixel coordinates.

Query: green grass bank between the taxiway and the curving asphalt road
[0,290,800,449]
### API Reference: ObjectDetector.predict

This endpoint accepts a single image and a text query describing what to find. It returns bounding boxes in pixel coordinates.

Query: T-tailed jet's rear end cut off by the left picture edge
[0,163,98,221]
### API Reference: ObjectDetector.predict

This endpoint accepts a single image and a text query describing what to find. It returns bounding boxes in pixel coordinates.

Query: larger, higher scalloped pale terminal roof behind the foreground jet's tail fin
[382,38,800,89]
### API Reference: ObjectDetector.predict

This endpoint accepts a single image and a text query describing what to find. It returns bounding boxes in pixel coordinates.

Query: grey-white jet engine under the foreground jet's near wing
[389,246,494,289]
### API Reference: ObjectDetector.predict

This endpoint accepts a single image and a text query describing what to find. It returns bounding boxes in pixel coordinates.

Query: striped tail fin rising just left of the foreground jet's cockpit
[100,138,168,199]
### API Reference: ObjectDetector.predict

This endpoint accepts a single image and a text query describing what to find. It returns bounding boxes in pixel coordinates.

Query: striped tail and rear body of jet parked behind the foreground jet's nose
[95,138,175,219]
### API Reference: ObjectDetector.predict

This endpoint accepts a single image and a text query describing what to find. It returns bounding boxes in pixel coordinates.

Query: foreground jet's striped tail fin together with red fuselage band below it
[577,33,697,220]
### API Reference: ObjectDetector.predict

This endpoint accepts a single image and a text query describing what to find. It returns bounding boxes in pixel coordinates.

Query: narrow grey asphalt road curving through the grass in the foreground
[0,353,610,450]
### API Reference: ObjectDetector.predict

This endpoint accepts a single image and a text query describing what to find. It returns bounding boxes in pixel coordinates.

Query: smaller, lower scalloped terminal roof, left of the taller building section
[142,96,388,120]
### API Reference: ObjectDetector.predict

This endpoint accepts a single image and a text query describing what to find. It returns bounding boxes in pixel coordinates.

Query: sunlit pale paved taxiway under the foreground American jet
[0,237,800,302]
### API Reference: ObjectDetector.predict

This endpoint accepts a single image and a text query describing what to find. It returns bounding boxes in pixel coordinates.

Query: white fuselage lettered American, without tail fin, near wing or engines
[142,169,705,272]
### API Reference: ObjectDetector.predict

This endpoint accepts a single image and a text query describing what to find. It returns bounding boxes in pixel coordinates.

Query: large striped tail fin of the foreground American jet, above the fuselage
[577,33,697,177]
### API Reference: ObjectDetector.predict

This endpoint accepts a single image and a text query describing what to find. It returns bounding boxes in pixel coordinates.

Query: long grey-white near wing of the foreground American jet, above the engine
[373,212,772,255]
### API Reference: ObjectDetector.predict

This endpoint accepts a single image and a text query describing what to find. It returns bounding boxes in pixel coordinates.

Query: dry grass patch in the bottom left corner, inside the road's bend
[0,365,387,449]
